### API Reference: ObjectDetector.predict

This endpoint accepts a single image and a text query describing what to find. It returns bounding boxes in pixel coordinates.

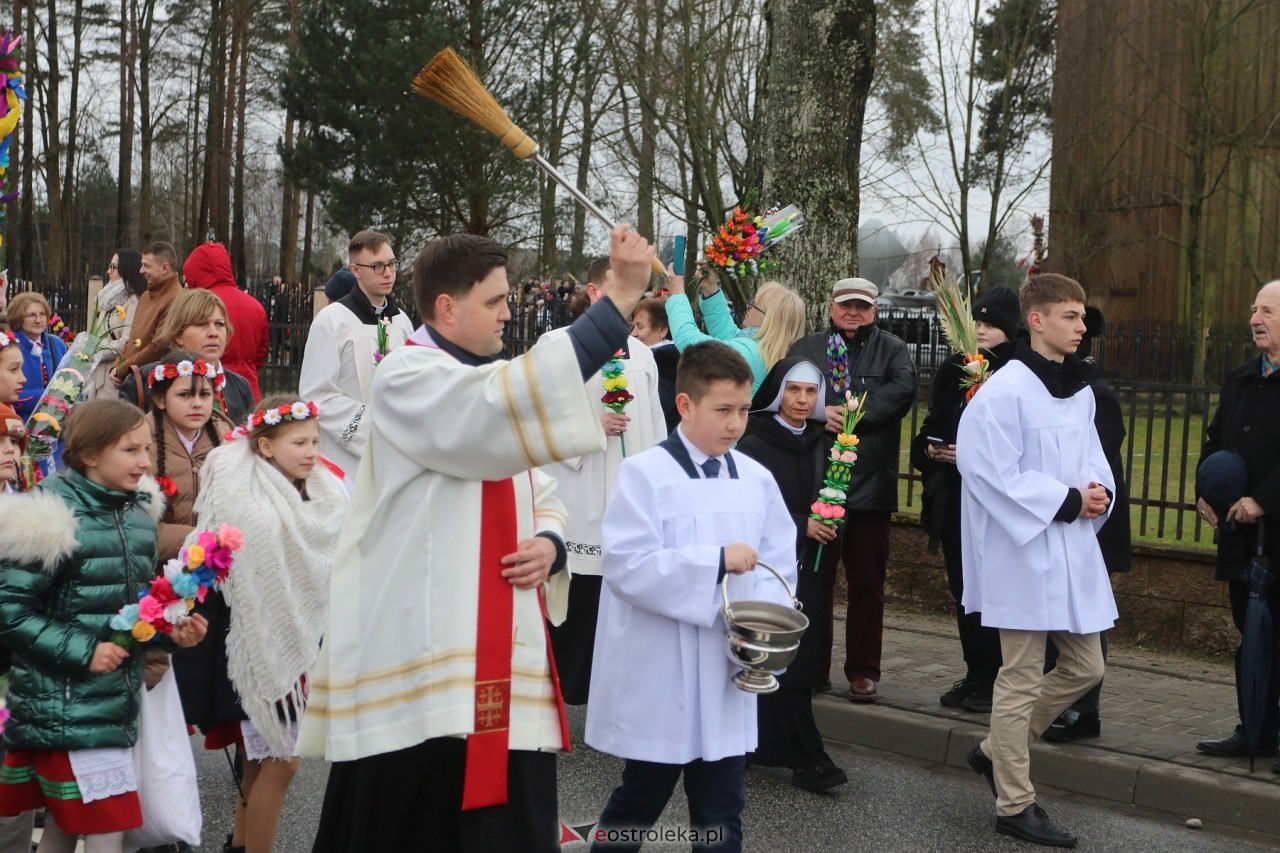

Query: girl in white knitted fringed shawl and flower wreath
[175,394,347,853]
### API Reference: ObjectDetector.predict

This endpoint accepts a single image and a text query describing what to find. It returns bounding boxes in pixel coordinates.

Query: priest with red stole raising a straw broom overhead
[298,225,654,853]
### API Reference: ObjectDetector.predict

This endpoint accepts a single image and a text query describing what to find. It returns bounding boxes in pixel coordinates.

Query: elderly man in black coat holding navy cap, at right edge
[1196,280,1280,774]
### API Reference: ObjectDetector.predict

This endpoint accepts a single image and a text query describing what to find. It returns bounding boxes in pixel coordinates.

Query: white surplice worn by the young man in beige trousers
[956,361,1124,634]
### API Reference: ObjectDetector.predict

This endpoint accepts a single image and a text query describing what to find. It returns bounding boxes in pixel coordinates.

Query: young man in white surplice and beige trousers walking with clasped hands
[956,274,1126,847]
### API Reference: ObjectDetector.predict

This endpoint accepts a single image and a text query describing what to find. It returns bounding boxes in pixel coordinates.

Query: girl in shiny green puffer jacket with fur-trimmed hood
[0,400,207,853]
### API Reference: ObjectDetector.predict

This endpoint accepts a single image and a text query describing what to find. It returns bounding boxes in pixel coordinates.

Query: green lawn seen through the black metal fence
[899,389,1217,549]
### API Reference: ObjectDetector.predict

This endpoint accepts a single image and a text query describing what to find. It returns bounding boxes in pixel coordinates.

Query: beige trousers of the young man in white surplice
[982,628,1103,817]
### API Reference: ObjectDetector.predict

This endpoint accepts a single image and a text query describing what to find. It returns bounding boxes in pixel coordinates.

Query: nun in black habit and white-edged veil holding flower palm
[736,357,849,792]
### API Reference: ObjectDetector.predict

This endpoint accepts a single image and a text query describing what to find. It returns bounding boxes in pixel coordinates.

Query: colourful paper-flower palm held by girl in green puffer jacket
[110,524,243,648]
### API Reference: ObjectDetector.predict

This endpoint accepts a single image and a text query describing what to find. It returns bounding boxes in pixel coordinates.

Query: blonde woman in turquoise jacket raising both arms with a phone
[667,273,804,394]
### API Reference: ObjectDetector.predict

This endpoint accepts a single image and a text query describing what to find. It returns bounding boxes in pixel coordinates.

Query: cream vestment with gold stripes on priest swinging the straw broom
[298,328,604,761]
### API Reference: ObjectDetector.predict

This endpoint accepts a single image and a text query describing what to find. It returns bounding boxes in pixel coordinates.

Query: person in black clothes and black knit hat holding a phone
[911,287,1019,713]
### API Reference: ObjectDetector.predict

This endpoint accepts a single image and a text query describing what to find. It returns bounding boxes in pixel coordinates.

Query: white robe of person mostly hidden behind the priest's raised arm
[538,329,667,576]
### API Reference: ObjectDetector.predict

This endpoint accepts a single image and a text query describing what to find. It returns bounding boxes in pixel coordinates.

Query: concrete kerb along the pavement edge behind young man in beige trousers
[813,695,1280,839]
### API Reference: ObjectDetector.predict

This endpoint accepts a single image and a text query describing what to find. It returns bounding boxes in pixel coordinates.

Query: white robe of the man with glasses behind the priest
[298,302,413,479]
